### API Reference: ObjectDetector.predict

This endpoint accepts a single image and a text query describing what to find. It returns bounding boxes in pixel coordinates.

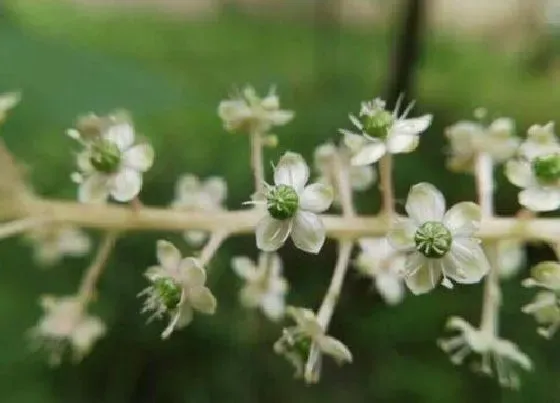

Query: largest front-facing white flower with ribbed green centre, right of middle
[388,183,490,294]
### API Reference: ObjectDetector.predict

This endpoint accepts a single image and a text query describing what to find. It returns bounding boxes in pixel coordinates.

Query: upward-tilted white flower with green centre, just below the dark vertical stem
[340,98,432,165]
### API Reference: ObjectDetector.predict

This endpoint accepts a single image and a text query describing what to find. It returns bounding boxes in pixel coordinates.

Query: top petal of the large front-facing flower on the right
[405,182,445,225]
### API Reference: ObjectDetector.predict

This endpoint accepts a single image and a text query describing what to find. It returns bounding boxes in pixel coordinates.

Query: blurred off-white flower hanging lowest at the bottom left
[30,295,105,365]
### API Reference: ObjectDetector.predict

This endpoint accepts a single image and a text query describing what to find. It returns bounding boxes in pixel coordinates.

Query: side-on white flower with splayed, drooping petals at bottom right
[438,317,533,389]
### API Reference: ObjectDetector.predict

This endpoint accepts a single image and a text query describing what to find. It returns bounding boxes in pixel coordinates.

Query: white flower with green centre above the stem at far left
[68,115,154,203]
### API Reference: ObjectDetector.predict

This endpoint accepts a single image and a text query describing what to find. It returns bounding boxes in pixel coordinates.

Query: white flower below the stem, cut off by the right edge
[522,261,560,339]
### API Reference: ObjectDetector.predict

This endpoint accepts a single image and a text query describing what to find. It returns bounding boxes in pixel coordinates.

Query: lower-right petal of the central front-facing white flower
[292,211,326,253]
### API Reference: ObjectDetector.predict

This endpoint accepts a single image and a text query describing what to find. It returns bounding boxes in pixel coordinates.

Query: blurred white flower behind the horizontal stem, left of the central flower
[171,174,227,247]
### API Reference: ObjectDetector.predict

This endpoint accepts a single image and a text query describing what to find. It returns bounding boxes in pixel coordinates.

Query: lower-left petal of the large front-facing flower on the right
[405,252,442,295]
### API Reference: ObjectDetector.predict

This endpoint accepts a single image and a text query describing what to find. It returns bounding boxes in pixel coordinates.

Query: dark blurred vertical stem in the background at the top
[386,0,426,107]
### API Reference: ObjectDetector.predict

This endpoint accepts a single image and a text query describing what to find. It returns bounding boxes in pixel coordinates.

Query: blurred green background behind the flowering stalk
[0,0,560,403]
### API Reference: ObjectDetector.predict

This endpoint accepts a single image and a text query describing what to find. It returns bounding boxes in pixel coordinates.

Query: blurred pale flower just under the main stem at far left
[26,224,91,266]
